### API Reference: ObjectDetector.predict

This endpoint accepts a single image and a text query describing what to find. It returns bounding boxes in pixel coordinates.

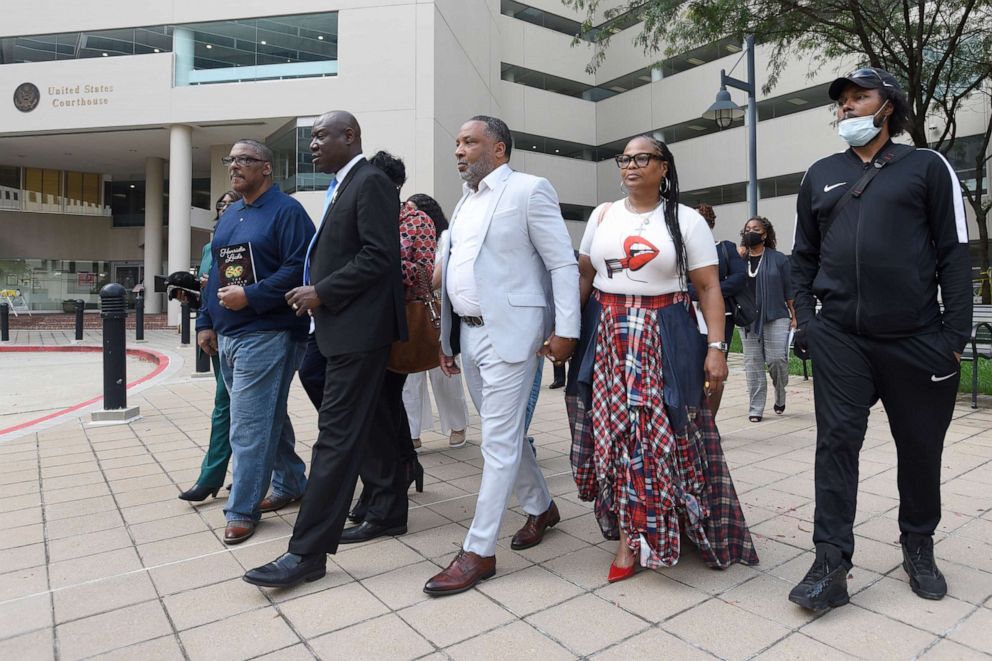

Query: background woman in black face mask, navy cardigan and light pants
[738,216,796,422]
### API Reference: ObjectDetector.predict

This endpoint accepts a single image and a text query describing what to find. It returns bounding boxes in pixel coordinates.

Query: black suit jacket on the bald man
[310,159,407,356]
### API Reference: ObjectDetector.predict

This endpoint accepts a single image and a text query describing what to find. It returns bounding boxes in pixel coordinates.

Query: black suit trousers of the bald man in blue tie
[289,346,392,555]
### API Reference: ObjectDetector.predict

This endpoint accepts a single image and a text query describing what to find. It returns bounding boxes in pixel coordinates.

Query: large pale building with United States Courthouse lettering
[0,0,988,318]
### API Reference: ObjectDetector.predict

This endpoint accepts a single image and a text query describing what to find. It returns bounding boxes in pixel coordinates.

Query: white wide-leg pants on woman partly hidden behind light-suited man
[403,367,468,438]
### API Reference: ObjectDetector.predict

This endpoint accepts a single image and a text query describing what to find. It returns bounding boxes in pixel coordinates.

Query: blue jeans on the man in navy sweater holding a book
[218,331,307,521]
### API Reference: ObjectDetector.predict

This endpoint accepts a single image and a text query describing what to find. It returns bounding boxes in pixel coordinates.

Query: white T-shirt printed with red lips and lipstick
[579,200,719,296]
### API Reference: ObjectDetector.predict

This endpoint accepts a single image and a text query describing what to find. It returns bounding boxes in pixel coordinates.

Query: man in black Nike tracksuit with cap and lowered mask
[789,68,972,610]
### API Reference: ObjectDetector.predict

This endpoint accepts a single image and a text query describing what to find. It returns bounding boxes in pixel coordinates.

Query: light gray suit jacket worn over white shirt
[438,165,579,363]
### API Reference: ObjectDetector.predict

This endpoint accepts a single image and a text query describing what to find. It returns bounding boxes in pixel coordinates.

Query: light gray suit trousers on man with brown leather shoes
[461,323,551,557]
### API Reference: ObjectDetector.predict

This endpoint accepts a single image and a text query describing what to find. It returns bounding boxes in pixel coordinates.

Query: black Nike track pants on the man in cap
[808,320,960,564]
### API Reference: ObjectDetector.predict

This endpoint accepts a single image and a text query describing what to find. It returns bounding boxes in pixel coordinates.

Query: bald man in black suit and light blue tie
[244,111,406,587]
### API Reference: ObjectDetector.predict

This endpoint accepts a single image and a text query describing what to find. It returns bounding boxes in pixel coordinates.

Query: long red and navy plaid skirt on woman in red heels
[569,291,758,568]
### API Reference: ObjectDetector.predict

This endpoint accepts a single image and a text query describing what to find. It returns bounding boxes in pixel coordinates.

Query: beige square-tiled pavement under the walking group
[0,331,992,661]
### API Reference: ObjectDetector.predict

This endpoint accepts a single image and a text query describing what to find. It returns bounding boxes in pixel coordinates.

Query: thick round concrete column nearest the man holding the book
[168,124,193,326]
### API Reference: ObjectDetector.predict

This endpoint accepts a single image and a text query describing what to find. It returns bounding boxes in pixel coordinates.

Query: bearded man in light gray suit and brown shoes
[424,115,579,596]
